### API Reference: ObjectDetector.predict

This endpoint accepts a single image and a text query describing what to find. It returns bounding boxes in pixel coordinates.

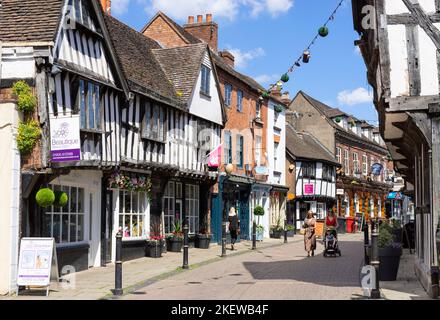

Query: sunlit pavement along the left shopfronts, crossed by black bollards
[0,236,286,300]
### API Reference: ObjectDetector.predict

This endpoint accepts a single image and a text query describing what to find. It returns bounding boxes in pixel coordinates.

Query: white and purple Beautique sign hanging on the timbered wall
[50,115,81,162]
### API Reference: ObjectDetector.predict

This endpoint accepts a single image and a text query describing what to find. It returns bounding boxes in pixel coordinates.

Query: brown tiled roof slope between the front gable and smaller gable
[105,15,179,103]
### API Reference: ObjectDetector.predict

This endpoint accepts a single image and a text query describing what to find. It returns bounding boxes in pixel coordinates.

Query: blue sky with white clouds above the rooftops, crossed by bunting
[112,0,377,125]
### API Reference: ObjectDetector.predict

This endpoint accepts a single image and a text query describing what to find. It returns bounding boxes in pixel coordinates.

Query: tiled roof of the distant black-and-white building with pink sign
[286,124,338,164]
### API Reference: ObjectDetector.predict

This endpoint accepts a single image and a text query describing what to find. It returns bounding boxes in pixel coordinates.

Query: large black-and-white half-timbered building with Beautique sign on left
[0,0,226,292]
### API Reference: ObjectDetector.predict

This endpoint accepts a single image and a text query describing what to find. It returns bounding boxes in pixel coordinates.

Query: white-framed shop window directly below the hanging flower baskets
[119,190,147,238]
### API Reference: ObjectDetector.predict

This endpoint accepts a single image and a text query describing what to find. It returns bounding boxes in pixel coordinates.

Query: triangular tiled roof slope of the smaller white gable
[152,43,208,102]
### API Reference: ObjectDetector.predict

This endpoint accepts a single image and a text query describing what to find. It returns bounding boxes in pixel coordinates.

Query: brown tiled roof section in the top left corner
[0,0,64,42]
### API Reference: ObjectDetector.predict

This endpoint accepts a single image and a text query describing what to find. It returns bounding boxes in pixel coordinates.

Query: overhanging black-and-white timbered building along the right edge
[352,0,440,297]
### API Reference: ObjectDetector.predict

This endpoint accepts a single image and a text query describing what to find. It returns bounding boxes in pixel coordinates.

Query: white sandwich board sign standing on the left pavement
[17,238,59,296]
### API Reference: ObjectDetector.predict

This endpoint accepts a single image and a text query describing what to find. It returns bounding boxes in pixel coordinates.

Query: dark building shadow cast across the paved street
[243,241,364,287]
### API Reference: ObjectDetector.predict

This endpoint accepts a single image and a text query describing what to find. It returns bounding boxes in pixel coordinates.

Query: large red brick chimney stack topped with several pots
[183,13,218,52]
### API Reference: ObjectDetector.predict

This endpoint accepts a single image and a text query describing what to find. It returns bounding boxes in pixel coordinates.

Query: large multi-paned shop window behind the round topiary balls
[43,185,86,243]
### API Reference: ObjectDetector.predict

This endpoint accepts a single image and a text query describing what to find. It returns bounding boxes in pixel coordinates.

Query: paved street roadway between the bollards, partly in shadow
[123,234,363,300]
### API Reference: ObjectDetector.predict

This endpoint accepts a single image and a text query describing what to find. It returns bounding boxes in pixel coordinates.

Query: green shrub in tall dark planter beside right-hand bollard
[378,223,402,281]
